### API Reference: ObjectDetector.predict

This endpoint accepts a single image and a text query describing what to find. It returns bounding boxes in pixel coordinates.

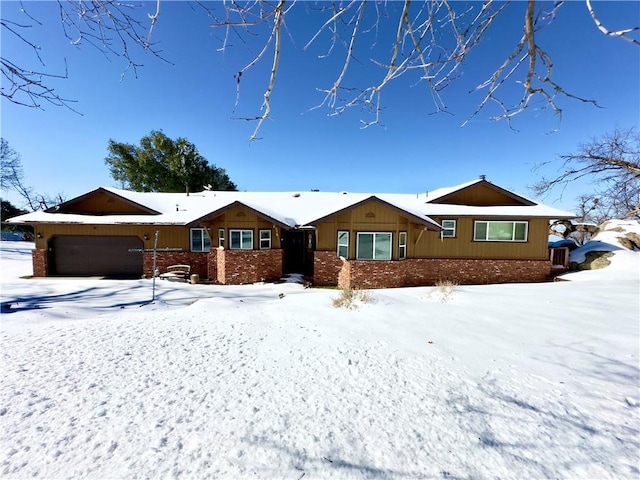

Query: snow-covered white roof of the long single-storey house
[9,179,575,228]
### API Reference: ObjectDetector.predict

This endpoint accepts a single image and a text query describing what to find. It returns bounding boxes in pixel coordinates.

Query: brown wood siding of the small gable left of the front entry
[194,206,282,250]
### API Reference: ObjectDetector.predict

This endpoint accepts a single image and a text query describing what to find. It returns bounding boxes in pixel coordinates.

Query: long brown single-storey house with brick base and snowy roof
[10,176,575,288]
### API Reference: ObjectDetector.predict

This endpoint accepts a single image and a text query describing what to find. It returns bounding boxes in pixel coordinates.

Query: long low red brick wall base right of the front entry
[338,258,551,288]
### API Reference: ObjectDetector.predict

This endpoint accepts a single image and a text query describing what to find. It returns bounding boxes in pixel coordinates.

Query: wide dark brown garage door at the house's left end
[48,235,143,277]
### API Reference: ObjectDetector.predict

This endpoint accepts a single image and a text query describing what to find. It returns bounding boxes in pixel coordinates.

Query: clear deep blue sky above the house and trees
[1,1,640,209]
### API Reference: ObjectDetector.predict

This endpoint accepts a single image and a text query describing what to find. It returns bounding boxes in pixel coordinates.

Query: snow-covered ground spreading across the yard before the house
[0,231,640,479]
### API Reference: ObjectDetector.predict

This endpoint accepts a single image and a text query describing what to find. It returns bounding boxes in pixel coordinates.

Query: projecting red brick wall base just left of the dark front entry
[217,249,283,285]
